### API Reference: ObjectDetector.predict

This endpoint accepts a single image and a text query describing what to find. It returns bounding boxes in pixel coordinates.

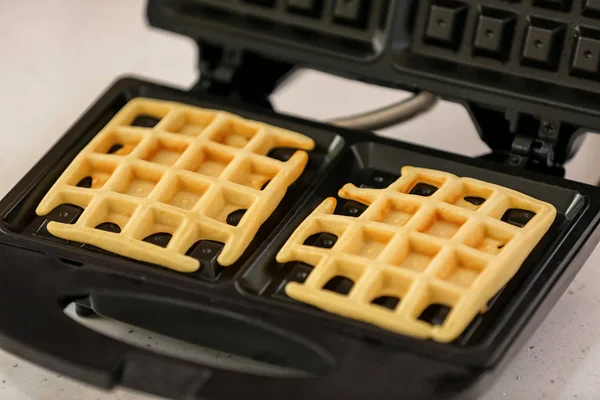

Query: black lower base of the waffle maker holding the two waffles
[0,78,600,399]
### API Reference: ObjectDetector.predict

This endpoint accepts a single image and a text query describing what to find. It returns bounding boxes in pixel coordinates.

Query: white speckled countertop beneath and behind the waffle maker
[0,0,600,400]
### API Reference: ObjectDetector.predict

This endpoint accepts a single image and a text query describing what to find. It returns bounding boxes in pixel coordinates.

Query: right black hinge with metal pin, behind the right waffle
[467,104,586,176]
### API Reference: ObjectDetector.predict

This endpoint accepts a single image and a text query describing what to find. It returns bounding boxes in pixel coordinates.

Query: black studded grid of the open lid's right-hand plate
[413,0,600,91]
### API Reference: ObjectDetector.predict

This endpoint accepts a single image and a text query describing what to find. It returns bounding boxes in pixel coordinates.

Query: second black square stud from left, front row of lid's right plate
[473,7,517,61]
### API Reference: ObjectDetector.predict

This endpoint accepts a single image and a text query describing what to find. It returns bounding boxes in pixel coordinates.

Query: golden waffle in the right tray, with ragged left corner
[277,166,556,342]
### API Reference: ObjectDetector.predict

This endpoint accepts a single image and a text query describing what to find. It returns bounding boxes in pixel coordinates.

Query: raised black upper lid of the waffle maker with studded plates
[147,0,600,172]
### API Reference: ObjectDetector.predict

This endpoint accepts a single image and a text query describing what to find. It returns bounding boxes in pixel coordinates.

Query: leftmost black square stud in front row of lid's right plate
[425,0,468,50]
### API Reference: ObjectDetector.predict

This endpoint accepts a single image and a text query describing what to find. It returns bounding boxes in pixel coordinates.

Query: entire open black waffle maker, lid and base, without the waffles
[0,0,600,400]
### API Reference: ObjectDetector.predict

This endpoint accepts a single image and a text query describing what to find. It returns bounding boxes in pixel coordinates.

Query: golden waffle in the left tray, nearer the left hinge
[36,98,314,272]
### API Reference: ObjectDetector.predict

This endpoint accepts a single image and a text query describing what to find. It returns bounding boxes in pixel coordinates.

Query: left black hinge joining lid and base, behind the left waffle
[192,41,293,108]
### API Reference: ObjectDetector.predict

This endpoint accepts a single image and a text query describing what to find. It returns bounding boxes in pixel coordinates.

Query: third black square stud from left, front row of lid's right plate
[522,18,566,71]
